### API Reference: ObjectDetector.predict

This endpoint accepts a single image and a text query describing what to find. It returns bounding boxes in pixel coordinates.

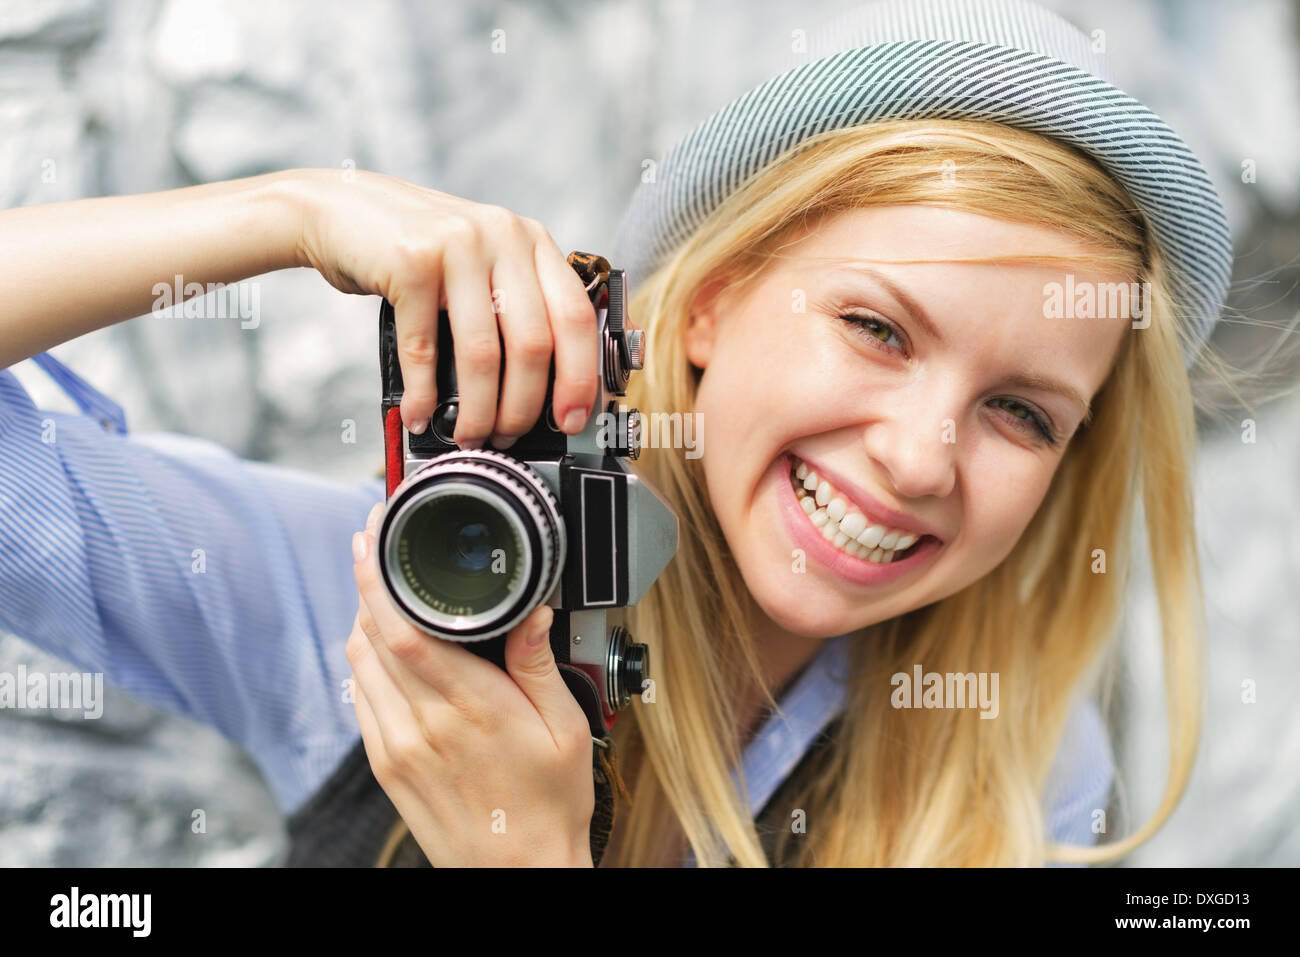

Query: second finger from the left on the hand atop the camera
[446,243,501,449]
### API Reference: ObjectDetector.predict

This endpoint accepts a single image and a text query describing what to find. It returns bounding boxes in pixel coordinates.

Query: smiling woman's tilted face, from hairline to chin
[686,205,1131,637]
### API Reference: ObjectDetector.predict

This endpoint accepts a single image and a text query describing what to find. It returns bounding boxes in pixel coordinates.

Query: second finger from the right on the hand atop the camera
[491,252,551,449]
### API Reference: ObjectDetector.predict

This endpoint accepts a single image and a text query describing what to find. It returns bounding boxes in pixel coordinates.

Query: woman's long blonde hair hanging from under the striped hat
[603,121,1204,866]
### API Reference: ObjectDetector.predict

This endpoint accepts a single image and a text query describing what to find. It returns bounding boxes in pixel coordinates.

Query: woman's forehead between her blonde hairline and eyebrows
[771,205,1138,395]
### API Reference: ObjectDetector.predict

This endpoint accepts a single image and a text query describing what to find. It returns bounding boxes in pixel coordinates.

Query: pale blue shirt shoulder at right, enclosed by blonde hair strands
[1045,701,1115,863]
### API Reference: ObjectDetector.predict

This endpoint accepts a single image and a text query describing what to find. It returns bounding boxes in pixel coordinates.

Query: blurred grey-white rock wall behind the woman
[0,0,1300,866]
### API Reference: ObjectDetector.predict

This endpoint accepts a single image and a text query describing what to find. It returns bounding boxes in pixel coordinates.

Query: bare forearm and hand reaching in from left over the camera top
[0,169,599,447]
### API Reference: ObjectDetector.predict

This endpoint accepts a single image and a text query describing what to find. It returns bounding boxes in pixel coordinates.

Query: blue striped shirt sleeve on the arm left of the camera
[0,369,384,813]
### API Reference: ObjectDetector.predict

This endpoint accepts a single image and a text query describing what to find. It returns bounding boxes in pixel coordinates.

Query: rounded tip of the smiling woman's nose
[863,394,957,502]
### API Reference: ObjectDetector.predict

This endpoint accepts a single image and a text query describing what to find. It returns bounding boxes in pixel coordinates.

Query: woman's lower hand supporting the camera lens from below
[347,506,595,867]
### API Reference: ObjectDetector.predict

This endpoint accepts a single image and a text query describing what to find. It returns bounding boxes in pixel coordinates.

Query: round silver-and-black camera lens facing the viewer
[378,450,564,641]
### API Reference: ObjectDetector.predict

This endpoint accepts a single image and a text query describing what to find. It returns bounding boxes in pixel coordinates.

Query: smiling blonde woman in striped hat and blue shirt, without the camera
[0,3,1248,866]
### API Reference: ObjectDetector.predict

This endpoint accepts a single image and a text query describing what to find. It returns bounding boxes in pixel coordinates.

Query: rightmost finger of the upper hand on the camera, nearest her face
[536,235,599,436]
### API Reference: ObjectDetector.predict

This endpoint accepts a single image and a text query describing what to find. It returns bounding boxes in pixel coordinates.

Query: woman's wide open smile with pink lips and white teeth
[779,455,943,584]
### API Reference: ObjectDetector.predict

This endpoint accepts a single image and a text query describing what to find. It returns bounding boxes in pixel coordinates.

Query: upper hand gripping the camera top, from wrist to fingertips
[287,170,599,449]
